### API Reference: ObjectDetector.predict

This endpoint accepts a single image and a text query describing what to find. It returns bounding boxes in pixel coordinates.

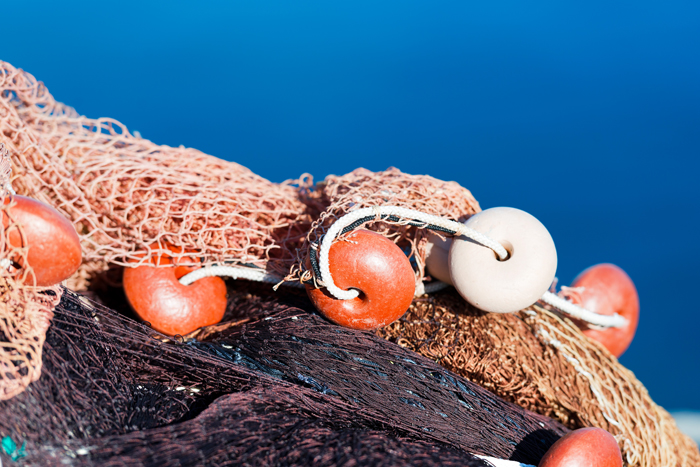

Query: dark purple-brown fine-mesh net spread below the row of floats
[0,283,567,465]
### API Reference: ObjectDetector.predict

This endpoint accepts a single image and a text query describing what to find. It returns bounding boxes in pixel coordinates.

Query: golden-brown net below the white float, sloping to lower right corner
[377,290,700,467]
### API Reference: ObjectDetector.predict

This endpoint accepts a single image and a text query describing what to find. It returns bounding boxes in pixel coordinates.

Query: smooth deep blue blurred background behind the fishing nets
[0,0,700,410]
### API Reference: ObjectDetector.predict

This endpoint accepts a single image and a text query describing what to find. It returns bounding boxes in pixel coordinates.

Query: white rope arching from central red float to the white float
[318,206,508,300]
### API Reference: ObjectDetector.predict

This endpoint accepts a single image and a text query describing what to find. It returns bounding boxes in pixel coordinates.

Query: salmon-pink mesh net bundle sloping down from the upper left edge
[0,62,310,289]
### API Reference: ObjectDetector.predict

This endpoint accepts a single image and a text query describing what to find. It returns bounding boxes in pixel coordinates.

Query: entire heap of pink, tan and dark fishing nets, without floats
[0,63,700,467]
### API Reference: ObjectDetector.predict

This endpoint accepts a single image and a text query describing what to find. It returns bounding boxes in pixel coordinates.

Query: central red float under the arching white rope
[306,230,416,330]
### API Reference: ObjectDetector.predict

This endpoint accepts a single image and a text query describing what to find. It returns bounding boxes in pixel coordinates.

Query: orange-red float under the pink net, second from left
[123,249,226,336]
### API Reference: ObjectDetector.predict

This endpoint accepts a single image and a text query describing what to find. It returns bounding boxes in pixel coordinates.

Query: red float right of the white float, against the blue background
[567,264,639,358]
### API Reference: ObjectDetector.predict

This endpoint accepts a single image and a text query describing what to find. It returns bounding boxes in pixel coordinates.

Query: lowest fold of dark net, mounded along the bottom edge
[47,389,488,467]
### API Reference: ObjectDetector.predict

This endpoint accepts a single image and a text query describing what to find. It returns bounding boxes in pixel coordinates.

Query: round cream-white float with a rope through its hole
[448,208,557,313]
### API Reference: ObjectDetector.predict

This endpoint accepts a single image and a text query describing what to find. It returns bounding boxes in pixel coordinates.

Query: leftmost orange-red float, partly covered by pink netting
[2,195,82,287]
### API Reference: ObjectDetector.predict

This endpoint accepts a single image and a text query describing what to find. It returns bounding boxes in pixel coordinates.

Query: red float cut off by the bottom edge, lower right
[537,428,622,467]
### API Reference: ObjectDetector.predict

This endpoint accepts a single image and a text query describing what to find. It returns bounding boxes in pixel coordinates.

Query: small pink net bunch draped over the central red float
[287,168,481,292]
